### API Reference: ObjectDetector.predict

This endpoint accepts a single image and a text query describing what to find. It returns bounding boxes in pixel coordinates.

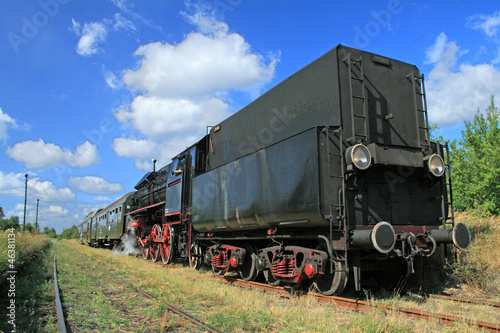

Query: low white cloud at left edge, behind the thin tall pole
[0,171,75,203]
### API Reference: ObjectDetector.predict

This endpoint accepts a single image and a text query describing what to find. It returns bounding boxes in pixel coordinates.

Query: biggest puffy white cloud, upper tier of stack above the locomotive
[122,30,276,98]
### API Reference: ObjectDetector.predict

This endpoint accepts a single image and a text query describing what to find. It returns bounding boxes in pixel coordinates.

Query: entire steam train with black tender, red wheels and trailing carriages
[81,45,470,295]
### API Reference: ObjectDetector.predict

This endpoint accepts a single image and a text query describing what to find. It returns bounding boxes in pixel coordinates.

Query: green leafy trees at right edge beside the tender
[450,96,500,214]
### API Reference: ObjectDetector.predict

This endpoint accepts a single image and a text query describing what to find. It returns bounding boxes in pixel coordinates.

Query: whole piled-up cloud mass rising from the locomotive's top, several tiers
[112,10,278,170]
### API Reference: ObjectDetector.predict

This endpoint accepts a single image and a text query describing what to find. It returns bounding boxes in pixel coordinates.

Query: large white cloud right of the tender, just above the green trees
[426,33,500,126]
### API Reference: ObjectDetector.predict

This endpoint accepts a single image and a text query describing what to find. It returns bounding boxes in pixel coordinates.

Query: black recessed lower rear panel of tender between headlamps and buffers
[346,166,442,226]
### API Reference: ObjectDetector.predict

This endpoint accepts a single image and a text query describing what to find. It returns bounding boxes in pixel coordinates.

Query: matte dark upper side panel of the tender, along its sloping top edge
[209,49,340,168]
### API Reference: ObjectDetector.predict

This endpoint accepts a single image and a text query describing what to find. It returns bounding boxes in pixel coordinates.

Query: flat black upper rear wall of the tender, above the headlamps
[336,46,424,148]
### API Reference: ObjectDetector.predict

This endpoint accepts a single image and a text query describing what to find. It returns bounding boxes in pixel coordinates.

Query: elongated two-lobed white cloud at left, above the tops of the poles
[7,139,99,169]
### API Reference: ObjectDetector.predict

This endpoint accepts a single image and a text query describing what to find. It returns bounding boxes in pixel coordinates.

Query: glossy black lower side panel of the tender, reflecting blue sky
[192,128,326,231]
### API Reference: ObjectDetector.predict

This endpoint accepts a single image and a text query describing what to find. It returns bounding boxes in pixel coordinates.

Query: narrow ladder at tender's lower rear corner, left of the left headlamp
[323,126,349,273]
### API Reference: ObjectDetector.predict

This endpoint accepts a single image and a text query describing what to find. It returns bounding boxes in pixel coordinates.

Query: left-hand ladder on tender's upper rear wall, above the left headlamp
[343,53,368,143]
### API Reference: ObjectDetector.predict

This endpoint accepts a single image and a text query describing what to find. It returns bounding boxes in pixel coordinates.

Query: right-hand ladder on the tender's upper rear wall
[406,72,430,148]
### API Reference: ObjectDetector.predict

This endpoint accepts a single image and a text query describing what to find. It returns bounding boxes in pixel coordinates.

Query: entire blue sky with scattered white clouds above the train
[0,0,500,232]
